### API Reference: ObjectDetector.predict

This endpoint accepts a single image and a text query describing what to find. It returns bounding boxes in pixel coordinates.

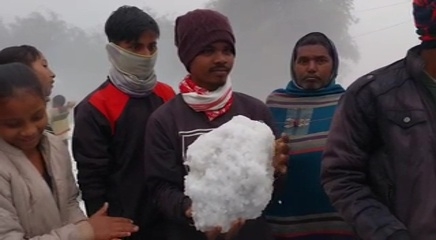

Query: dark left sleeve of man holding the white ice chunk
[144,114,191,224]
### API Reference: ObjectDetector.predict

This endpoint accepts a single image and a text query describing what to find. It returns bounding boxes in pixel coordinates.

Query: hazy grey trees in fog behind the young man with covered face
[0,9,183,100]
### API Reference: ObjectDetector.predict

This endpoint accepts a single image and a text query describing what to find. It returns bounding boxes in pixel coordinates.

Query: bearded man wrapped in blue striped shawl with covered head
[266,32,353,240]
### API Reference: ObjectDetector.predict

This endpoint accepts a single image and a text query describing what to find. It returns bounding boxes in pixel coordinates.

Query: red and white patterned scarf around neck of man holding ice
[179,75,233,121]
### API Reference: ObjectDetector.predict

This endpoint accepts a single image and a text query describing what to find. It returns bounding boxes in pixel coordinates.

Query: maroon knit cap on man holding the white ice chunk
[174,9,235,72]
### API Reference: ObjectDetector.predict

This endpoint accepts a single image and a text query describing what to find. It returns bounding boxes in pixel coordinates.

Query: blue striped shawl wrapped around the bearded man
[266,91,354,240]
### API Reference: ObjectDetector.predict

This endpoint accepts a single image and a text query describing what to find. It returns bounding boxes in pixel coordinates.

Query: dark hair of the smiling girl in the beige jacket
[0,63,45,99]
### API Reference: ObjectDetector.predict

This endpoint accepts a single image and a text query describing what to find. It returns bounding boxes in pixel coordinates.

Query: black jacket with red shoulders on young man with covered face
[73,80,175,236]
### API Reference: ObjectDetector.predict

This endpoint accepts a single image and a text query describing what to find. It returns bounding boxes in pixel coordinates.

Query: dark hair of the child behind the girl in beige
[0,45,41,67]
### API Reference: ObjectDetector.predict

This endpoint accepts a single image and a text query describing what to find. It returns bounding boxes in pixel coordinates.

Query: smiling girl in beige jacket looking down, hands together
[0,63,138,240]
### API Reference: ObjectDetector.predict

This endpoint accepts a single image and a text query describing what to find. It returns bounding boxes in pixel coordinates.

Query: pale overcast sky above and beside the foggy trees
[0,0,419,85]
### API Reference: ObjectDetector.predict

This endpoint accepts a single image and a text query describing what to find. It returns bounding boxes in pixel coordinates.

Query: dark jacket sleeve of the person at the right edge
[321,86,406,240]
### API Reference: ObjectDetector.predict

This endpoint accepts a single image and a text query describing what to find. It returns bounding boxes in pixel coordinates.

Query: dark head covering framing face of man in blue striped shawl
[291,32,339,79]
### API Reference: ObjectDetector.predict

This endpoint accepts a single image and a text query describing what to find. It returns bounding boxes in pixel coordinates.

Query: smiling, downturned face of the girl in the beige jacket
[0,89,47,151]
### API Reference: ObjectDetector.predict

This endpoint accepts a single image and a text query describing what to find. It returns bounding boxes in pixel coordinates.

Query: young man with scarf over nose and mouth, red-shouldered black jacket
[73,6,175,240]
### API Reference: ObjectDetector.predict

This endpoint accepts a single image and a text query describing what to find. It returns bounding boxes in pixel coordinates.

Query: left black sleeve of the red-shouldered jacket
[73,102,111,216]
